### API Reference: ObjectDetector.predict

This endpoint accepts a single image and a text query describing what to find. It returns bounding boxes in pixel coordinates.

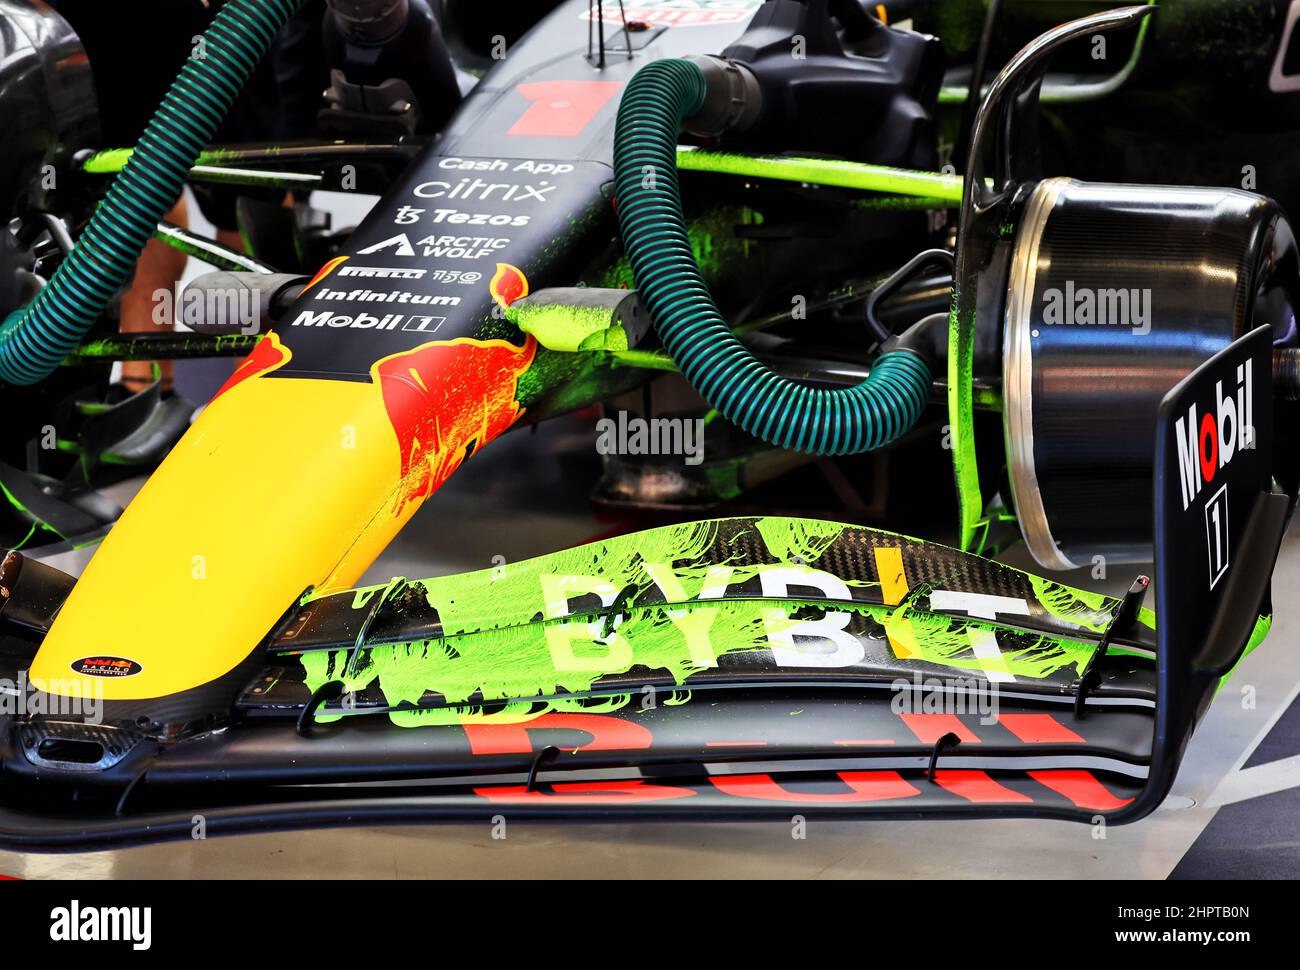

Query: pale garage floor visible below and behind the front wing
[0,408,1300,879]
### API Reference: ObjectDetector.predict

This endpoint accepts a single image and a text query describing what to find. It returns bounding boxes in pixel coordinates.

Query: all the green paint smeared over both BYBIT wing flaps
[302,518,1170,726]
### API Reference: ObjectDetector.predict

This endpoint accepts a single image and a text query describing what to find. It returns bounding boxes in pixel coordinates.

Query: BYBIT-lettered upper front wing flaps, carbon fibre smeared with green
[292,516,1170,724]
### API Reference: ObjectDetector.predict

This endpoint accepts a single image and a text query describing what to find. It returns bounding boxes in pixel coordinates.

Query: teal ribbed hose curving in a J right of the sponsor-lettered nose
[614,59,931,455]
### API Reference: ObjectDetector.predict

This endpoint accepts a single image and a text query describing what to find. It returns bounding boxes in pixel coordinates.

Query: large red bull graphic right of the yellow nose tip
[371,337,537,515]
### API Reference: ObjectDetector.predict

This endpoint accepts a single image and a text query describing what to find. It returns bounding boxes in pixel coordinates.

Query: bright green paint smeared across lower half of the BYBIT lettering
[302,590,1096,727]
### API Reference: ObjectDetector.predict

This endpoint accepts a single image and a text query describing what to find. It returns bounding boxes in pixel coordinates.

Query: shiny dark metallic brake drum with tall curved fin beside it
[948,5,1300,559]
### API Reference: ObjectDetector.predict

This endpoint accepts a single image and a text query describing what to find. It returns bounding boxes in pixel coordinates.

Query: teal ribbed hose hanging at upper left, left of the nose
[0,0,304,384]
